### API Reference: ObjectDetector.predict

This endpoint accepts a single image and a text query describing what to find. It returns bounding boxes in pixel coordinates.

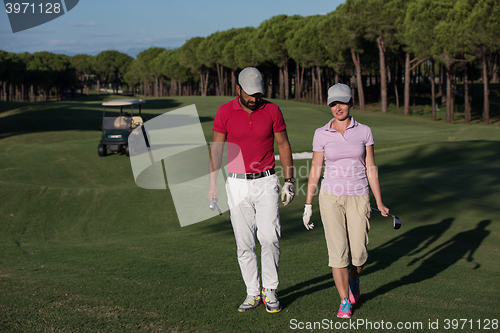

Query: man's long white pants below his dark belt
[226,175,281,295]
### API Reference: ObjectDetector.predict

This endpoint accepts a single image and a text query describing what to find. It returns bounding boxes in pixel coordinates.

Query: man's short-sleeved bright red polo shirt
[213,97,286,173]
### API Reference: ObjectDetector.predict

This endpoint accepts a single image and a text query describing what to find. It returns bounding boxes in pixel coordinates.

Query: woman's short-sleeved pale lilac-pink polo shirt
[313,117,374,197]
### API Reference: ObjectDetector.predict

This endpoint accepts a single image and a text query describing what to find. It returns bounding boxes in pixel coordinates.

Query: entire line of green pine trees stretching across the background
[0,0,500,124]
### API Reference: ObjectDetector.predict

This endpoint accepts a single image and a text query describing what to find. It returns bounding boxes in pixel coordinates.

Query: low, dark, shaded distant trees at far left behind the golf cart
[0,50,134,102]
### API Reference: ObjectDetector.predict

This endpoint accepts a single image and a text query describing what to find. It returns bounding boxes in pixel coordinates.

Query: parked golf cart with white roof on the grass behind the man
[97,99,146,156]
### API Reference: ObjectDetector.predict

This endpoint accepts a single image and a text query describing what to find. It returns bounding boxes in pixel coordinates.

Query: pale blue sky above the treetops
[0,0,345,56]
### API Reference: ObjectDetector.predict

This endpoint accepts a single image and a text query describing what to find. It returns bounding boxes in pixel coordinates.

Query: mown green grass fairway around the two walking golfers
[0,95,500,333]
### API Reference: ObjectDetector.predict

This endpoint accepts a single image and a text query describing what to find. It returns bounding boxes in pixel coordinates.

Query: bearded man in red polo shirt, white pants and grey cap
[208,67,295,313]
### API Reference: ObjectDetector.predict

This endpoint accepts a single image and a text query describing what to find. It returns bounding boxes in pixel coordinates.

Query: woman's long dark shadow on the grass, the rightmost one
[358,220,491,306]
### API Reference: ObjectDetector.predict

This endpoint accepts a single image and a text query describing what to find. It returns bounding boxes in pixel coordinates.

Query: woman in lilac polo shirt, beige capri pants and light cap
[302,83,389,318]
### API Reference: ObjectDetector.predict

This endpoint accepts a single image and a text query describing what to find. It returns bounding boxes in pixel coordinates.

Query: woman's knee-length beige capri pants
[319,190,370,268]
